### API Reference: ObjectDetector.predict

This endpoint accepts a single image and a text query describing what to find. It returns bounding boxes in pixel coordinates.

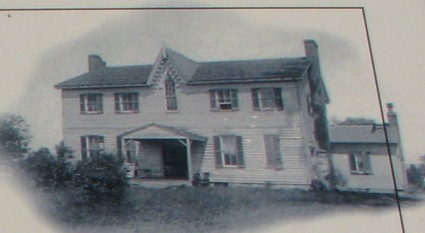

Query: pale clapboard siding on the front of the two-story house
[63,82,312,185]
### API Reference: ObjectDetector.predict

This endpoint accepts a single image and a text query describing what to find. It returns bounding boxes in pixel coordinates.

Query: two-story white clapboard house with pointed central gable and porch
[56,40,329,187]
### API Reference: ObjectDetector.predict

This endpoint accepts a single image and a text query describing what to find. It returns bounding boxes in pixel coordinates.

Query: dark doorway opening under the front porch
[163,145,188,179]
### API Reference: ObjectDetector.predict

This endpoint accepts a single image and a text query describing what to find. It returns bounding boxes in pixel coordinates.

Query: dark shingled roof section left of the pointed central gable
[55,65,153,89]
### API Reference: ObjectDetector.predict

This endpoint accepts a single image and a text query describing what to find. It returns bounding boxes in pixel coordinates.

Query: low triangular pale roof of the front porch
[118,123,207,141]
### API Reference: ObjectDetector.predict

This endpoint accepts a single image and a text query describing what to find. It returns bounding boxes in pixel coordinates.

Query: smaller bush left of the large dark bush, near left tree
[22,148,72,191]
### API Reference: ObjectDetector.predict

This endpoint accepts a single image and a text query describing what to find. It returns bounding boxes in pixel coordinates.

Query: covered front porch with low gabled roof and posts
[117,124,207,182]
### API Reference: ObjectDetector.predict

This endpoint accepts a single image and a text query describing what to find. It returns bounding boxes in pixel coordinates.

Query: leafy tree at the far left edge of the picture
[0,114,31,160]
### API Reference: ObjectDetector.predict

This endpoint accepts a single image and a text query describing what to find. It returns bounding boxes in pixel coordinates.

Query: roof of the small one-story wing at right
[329,124,398,144]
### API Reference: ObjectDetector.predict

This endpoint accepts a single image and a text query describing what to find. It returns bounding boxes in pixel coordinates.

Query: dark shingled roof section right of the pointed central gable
[189,58,309,84]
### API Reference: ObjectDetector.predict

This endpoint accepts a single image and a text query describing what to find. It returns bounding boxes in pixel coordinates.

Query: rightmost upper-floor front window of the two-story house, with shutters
[252,88,283,111]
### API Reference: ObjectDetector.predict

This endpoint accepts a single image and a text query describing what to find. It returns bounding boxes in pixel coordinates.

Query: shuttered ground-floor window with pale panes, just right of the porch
[214,135,245,168]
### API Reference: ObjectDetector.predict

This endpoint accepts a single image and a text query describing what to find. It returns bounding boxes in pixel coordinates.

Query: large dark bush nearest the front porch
[73,154,128,204]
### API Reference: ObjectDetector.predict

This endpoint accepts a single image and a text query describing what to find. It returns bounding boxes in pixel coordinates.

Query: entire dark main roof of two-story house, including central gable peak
[55,47,310,89]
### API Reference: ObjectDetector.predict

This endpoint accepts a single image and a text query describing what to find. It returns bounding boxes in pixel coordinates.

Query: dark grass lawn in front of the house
[42,187,408,233]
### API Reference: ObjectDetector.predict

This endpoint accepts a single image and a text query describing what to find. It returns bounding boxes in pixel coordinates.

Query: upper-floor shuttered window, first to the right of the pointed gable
[210,89,239,111]
